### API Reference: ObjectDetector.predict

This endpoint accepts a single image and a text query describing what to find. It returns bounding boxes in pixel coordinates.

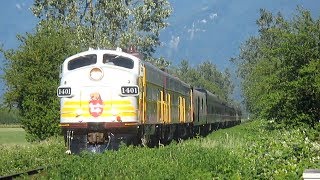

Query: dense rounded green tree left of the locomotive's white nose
[2,23,79,141]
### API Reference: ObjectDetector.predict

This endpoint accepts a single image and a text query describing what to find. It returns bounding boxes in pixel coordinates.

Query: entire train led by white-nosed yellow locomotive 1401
[57,48,241,153]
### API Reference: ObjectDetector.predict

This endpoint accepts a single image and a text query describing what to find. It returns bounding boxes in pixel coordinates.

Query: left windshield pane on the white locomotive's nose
[68,54,97,70]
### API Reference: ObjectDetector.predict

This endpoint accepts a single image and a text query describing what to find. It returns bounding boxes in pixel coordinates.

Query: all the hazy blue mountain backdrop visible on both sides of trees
[0,0,320,102]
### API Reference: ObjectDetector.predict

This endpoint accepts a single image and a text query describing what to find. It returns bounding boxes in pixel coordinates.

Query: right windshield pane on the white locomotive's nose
[103,54,134,69]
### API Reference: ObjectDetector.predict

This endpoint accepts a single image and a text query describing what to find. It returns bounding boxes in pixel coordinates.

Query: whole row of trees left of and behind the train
[0,0,232,141]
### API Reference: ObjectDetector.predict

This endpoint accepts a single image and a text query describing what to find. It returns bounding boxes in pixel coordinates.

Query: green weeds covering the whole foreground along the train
[0,121,320,179]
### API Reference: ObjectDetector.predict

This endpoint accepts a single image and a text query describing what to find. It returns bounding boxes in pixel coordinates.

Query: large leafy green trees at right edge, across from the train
[233,8,320,127]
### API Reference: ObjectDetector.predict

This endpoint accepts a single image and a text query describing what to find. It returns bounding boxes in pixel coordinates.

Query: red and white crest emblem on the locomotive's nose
[89,92,103,117]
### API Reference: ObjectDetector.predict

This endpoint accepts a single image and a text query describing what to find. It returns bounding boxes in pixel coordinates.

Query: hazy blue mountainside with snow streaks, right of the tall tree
[158,0,320,70]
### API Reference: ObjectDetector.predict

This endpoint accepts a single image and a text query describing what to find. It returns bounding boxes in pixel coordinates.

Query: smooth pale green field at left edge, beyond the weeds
[0,127,27,144]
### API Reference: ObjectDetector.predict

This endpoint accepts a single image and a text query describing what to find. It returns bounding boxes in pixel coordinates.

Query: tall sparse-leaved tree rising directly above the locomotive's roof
[32,0,171,59]
